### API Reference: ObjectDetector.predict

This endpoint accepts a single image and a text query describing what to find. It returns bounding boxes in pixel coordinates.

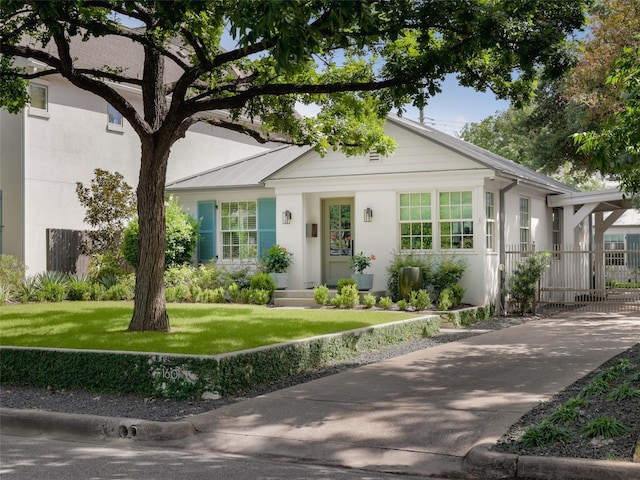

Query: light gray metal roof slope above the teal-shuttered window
[167,145,313,190]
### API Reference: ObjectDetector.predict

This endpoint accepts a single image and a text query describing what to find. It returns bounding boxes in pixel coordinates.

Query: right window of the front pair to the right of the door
[438,191,473,250]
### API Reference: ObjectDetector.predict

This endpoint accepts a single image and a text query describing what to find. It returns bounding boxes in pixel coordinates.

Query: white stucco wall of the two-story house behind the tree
[3,73,267,274]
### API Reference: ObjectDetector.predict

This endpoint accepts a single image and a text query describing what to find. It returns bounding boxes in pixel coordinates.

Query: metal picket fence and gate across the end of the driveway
[504,245,640,312]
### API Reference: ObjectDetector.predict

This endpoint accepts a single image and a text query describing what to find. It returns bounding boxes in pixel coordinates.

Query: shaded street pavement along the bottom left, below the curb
[0,435,444,480]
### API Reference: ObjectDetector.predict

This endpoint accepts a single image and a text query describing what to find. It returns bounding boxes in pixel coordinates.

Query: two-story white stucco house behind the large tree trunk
[0,37,272,275]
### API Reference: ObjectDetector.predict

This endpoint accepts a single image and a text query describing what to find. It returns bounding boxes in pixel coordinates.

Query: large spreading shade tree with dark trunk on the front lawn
[0,0,589,331]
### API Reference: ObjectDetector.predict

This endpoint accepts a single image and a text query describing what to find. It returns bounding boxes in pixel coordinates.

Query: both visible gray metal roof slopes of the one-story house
[167,115,577,193]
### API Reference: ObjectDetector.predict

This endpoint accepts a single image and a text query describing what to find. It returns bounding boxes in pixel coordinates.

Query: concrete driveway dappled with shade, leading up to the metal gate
[2,312,640,480]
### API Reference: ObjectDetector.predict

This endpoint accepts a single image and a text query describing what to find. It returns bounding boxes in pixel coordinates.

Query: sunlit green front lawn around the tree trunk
[0,302,415,355]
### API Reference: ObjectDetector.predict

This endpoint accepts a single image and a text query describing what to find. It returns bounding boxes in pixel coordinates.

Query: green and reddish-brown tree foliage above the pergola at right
[461,0,640,193]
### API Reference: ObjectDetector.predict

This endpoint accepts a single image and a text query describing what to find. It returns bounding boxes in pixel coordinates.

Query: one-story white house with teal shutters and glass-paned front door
[167,116,584,305]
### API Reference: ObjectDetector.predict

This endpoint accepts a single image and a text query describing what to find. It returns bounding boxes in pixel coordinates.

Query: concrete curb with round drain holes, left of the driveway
[0,408,197,441]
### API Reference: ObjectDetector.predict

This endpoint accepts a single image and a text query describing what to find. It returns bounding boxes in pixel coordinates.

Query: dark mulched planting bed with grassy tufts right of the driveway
[493,344,640,461]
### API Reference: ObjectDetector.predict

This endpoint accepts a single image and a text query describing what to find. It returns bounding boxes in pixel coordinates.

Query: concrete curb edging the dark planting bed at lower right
[463,444,640,480]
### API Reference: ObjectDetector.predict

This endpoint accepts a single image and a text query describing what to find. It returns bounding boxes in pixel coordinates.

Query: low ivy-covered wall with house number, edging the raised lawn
[0,317,440,399]
